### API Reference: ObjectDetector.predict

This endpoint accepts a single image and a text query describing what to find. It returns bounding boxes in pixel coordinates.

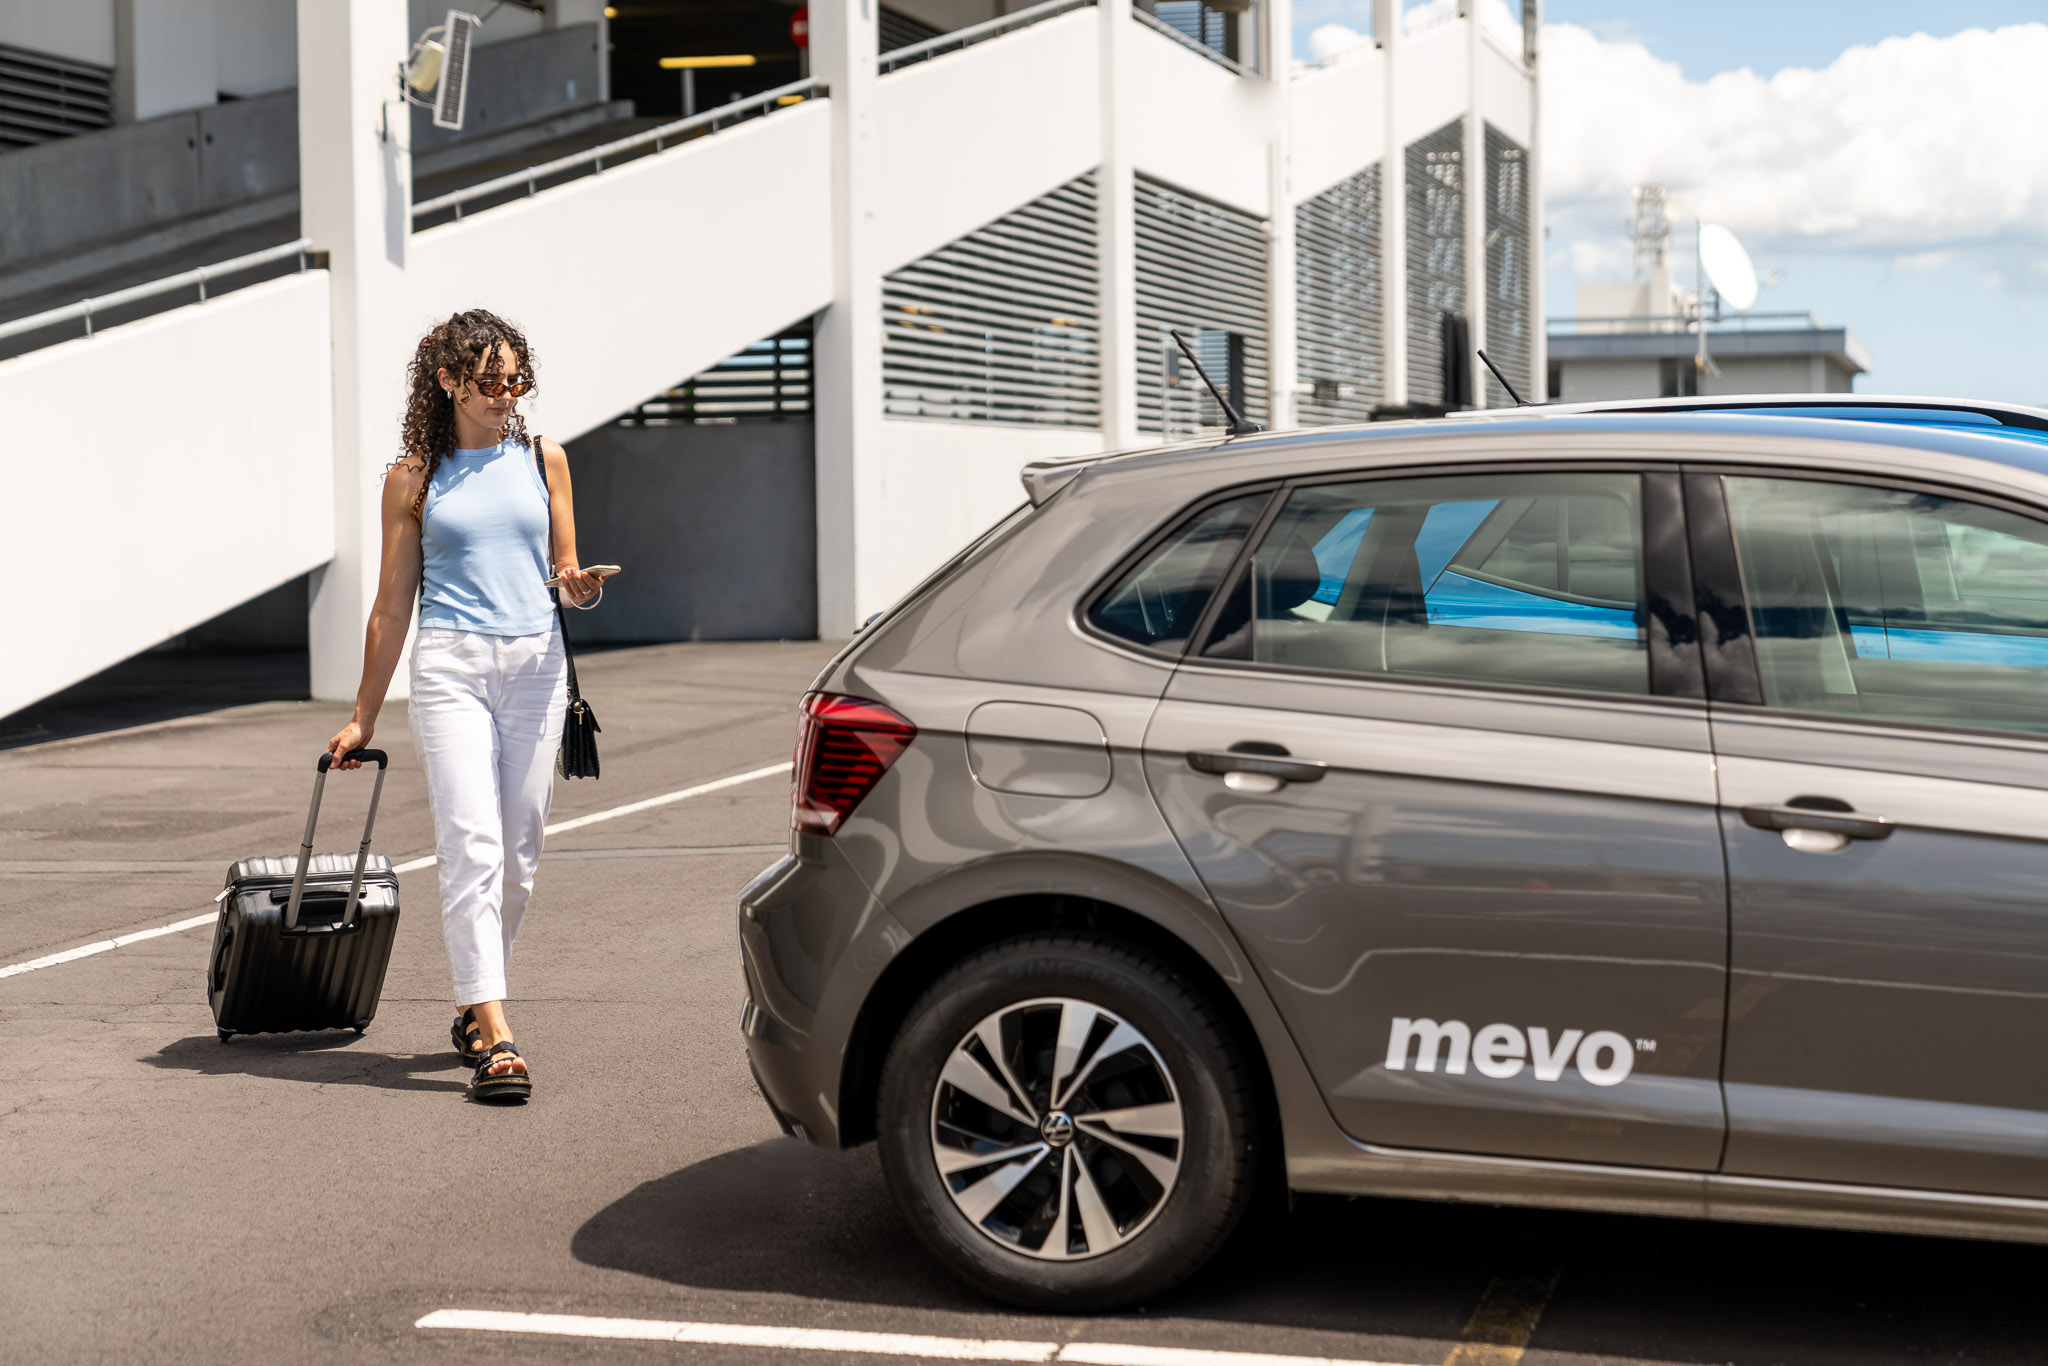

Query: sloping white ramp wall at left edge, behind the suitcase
[0,270,334,715]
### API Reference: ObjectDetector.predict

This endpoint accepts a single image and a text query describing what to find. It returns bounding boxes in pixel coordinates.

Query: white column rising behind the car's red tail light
[811,0,887,639]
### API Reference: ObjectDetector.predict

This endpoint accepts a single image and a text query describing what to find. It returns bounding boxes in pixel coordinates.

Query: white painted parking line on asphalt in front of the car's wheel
[414,1309,1386,1366]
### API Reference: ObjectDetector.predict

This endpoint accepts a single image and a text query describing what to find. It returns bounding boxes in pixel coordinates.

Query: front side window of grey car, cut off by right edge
[1726,475,2048,731]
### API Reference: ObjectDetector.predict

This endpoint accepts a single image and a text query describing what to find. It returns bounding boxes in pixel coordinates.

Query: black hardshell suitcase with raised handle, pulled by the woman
[207,750,397,1042]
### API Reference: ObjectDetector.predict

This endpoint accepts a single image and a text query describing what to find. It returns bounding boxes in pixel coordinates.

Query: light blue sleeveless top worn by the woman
[420,440,555,635]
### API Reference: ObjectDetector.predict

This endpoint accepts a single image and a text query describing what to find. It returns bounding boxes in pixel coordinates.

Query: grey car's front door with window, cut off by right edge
[1688,471,2048,1196]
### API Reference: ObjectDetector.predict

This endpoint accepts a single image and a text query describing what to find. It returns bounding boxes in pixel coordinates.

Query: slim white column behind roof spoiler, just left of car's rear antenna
[1096,0,1139,451]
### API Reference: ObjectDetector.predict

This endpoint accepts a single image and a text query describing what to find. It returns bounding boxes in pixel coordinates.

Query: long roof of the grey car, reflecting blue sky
[1024,409,2048,504]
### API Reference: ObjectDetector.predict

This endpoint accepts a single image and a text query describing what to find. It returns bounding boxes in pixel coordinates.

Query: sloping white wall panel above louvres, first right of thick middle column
[872,10,1102,272]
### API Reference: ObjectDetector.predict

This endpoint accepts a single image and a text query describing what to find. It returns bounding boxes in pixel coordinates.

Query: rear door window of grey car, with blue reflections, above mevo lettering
[1251,473,1651,692]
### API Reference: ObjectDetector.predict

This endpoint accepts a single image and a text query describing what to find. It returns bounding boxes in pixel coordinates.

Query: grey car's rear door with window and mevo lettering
[1145,465,1726,1169]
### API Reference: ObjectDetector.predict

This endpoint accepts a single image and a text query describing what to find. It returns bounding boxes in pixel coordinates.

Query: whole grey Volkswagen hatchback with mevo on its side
[739,399,2048,1309]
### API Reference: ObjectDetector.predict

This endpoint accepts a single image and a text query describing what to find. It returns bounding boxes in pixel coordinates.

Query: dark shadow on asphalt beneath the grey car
[571,1139,2048,1366]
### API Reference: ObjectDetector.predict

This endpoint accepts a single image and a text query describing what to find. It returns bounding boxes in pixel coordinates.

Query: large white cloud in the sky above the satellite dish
[1542,23,2048,259]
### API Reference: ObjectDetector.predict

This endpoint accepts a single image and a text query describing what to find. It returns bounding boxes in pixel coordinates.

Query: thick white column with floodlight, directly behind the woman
[299,0,418,700]
